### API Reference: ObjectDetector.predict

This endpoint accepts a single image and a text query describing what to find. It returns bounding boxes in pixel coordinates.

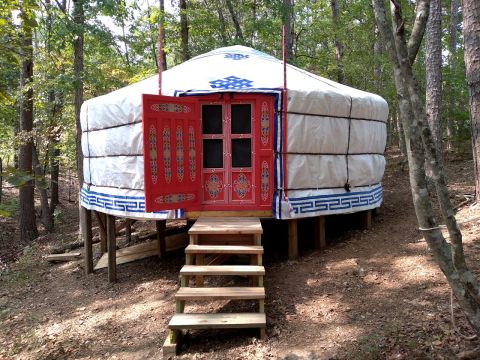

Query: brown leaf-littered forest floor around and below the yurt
[0,148,480,360]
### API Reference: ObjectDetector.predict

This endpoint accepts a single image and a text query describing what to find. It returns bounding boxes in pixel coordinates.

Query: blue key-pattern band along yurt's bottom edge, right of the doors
[288,185,383,214]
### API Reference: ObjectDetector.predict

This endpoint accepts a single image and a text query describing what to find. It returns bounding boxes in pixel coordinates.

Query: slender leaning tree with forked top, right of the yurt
[372,0,480,333]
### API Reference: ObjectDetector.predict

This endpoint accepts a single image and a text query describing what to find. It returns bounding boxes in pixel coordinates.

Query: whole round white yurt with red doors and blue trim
[80,46,388,220]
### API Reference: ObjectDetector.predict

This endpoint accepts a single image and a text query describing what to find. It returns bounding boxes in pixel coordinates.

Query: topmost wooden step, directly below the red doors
[188,217,263,235]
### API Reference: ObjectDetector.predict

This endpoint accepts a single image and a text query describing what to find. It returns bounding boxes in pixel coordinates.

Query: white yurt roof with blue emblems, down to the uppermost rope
[82,45,388,129]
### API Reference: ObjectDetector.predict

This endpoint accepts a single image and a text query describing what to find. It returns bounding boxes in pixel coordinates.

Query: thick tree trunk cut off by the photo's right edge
[463,0,480,201]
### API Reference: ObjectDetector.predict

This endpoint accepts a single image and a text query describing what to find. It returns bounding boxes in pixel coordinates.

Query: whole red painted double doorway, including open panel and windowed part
[142,93,274,212]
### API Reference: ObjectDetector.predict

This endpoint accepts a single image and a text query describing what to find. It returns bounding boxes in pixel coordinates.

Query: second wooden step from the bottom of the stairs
[175,287,265,300]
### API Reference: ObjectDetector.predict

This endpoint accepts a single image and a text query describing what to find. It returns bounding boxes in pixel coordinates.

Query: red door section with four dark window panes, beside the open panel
[200,94,274,210]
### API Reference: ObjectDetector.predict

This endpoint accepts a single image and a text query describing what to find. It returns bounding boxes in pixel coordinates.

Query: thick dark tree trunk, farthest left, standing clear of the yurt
[18,1,38,241]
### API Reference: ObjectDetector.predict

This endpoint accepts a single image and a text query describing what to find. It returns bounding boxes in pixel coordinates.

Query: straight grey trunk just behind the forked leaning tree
[425,0,443,169]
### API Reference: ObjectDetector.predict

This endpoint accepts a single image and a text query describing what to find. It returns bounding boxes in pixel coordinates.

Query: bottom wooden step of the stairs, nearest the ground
[168,313,267,330]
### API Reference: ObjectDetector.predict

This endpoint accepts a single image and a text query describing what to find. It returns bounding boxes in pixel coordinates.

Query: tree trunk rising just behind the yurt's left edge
[73,0,85,188]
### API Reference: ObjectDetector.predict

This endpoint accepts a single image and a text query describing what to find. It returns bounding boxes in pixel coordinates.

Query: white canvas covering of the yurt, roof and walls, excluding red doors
[81,46,388,219]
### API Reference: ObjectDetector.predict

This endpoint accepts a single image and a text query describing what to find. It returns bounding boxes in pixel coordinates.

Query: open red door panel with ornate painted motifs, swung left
[142,95,201,212]
